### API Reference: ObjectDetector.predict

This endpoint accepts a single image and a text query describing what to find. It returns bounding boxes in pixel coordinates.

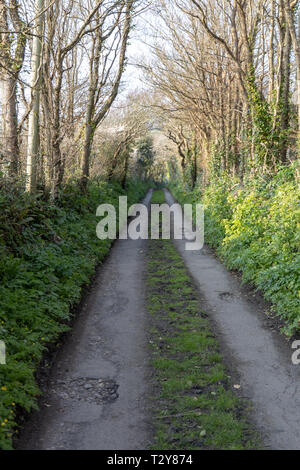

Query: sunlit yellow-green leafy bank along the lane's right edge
[171,164,300,336]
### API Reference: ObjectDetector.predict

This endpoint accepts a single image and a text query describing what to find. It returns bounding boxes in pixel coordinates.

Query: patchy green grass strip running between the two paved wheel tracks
[147,192,258,450]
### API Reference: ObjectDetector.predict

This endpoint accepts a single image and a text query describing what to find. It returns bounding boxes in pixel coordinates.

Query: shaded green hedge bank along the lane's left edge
[0,181,147,449]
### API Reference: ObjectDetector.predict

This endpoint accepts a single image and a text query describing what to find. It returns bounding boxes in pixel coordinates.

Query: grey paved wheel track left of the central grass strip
[18,192,151,450]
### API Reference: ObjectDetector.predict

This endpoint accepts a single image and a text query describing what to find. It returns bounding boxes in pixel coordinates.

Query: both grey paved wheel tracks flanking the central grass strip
[18,191,300,450]
